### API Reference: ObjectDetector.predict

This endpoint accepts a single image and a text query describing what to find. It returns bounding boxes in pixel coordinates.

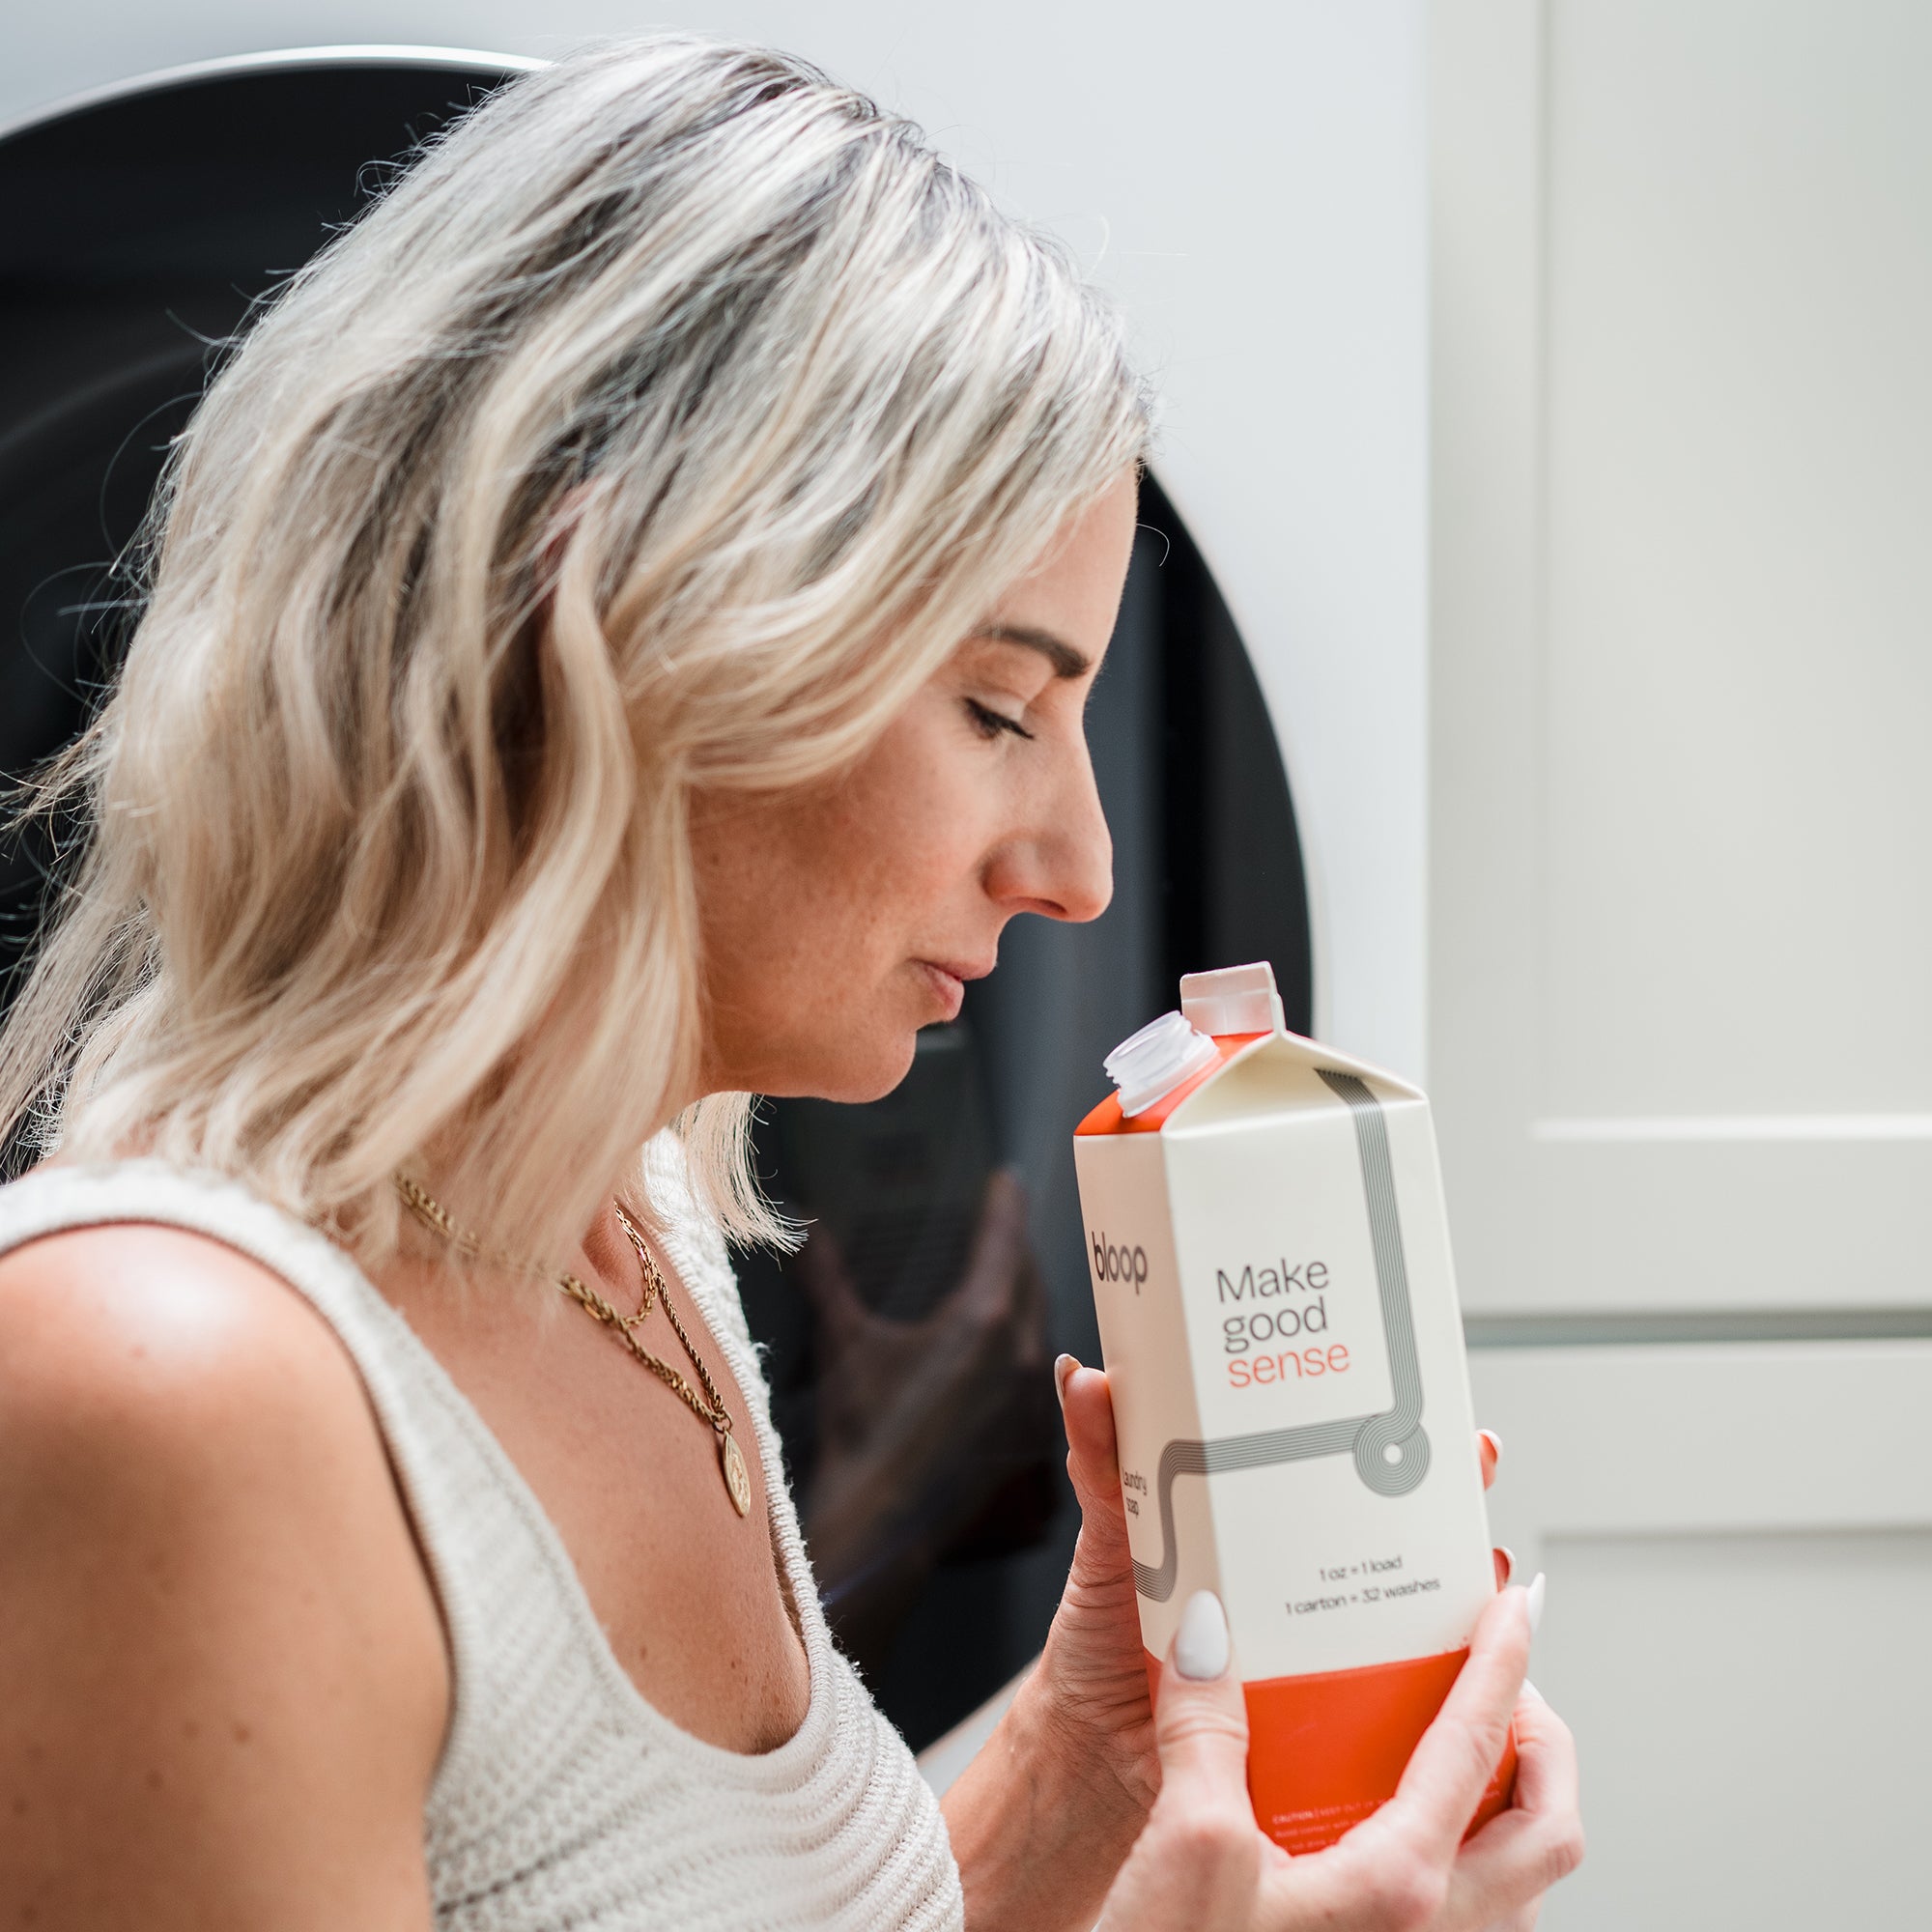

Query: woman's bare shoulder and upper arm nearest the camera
[0,1225,448,1926]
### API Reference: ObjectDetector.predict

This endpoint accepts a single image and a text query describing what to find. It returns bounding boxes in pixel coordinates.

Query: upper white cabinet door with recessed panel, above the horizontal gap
[1430,0,1932,1316]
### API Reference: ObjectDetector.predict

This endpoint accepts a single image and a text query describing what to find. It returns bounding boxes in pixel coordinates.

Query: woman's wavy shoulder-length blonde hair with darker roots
[0,37,1148,1258]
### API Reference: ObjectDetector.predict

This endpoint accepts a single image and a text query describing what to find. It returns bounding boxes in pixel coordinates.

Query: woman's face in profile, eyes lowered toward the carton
[694,475,1136,1101]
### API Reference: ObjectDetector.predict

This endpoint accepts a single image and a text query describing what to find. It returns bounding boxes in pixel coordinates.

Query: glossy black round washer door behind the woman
[0,50,1310,1747]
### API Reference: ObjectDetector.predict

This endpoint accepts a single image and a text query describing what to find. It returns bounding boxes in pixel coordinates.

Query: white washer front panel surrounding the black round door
[0,0,1426,1074]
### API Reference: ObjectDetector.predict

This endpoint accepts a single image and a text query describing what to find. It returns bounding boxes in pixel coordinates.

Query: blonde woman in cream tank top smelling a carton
[0,39,1578,1932]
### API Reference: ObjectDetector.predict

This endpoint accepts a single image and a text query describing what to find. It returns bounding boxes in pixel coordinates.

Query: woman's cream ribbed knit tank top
[0,1142,964,1932]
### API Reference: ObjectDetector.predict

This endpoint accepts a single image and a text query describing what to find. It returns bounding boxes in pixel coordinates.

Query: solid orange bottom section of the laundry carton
[1148,1650,1517,1853]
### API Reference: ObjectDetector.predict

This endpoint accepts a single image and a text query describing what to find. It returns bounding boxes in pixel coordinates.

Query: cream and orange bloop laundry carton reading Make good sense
[1074,964,1515,1853]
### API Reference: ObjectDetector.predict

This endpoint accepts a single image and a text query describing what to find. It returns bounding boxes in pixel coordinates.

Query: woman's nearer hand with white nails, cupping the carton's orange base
[1101,1590,1582,1932]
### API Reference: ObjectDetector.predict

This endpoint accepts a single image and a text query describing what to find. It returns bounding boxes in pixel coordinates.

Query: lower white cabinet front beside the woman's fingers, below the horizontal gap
[1470,1341,1932,1932]
